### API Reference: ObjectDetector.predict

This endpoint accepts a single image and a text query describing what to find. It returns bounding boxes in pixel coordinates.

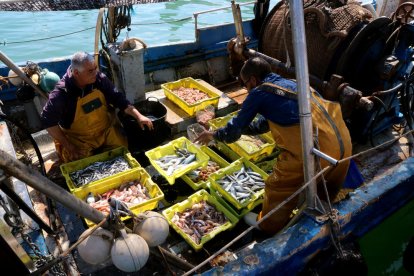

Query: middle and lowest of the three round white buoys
[111,229,149,272]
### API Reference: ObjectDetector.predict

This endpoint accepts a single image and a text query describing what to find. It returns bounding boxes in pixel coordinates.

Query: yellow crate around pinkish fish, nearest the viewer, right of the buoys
[162,189,239,251]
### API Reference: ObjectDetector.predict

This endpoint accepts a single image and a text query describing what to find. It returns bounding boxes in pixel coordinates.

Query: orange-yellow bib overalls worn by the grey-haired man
[55,89,128,163]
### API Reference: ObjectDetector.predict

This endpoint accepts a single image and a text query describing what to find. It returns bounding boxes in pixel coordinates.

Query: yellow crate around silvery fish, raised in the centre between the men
[145,137,209,185]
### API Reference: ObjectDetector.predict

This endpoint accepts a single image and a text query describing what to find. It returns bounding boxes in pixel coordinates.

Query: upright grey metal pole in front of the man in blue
[289,0,316,208]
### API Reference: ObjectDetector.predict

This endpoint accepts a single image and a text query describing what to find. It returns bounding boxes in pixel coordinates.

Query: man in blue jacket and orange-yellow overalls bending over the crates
[195,57,352,234]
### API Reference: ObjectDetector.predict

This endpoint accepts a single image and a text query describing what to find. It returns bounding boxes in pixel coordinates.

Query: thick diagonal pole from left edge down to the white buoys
[0,149,106,226]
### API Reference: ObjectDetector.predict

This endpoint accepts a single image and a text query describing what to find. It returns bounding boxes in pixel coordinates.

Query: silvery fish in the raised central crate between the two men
[155,145,196,176]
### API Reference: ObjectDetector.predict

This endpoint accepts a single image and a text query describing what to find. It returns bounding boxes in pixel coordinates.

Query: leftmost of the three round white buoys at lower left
[78,228,114,264]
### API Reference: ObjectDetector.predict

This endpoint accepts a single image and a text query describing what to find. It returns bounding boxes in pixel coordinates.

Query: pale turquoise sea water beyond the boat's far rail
[0,0,278,63]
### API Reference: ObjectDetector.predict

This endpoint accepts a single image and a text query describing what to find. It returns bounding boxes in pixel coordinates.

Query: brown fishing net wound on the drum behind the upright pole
[259,0,373,79]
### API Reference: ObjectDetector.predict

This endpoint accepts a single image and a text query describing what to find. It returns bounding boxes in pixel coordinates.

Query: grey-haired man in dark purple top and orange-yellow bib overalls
[41,52,153,163]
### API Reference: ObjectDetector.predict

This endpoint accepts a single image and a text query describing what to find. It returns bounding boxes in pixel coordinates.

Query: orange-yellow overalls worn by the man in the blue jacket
[258,83,352,234]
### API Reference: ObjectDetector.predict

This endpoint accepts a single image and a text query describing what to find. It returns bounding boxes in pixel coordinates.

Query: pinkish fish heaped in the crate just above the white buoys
[86,180,151,215]
